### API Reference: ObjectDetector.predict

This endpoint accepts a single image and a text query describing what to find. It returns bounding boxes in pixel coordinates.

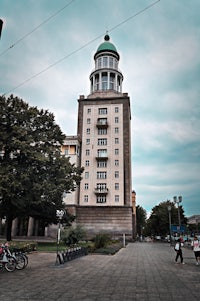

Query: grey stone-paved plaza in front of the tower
[0,242,200,301]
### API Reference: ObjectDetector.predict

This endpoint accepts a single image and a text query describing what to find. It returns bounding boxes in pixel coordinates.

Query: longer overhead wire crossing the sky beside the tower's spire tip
[3,0,160,96]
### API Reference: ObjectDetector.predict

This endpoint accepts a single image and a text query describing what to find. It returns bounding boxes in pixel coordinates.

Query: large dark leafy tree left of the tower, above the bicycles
[0,95,82,241]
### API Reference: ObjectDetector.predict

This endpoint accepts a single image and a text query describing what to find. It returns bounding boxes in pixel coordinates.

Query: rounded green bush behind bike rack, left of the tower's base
[61,225,86,246]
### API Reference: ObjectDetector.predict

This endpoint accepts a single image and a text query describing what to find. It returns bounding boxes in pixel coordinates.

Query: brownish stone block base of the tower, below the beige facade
[68,206,133,238]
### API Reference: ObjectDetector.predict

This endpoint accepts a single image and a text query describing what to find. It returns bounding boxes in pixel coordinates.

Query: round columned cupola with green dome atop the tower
[90,34,123,94]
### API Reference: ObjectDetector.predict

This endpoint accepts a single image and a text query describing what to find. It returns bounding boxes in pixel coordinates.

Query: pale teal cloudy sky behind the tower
[0,0,200,216]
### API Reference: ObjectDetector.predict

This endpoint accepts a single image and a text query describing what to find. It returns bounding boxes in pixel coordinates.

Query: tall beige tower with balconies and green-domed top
[77,35,133,235]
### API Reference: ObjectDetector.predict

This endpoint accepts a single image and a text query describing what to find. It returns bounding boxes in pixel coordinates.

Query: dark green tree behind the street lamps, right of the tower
[145,201,187,237]
